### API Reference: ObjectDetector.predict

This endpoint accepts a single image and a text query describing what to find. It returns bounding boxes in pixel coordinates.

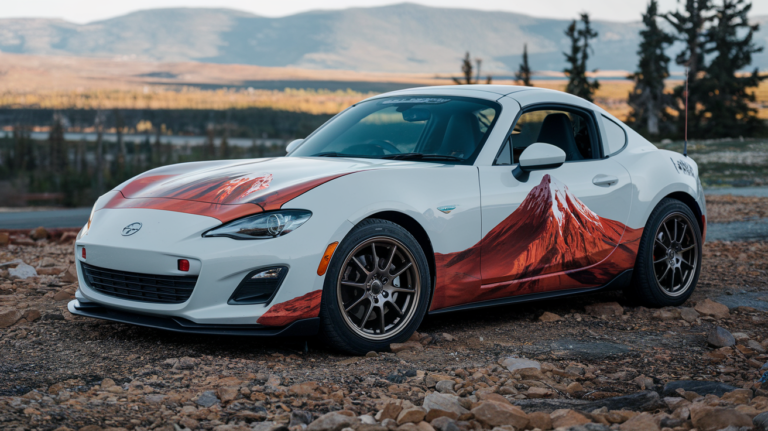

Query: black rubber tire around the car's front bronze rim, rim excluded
[320,219,432,354]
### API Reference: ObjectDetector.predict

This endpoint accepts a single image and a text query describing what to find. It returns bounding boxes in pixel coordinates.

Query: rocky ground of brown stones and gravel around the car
[0,198,768,431]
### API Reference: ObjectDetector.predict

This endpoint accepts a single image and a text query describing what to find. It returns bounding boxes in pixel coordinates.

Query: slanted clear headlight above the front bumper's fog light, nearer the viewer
[203,210,312,239]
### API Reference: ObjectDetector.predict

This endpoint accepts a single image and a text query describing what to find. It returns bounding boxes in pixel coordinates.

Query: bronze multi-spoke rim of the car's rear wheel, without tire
[653,212,699,296]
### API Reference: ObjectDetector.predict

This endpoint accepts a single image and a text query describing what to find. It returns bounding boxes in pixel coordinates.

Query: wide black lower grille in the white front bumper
[82,263,197,304]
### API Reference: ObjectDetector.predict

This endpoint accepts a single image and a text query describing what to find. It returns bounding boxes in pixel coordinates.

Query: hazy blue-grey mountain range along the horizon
[0,3,768,73]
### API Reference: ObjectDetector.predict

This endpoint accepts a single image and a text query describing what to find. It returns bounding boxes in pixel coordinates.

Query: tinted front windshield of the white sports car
[291,96,501,163]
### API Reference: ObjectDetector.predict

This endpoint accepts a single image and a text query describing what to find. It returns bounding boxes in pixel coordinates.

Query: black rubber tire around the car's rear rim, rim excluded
[632,198,703,307]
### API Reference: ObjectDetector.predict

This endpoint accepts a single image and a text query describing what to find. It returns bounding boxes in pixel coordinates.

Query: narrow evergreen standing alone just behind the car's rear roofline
[563,13,600,102]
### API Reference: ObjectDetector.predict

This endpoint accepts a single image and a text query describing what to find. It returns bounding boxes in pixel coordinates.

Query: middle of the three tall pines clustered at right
[664,0,713,134]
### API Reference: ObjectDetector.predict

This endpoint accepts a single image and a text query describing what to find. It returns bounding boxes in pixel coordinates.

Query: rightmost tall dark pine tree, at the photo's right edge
[699,0,766,137]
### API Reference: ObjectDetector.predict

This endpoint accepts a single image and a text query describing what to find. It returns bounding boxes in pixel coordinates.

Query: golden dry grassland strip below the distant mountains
[0,53,768,119]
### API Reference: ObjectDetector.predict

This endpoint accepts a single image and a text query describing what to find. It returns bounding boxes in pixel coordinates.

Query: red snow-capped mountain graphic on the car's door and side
[432,175,642,310]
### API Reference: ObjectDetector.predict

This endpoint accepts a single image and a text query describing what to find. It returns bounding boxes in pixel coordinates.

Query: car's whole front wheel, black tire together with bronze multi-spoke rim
[320,219,432,355]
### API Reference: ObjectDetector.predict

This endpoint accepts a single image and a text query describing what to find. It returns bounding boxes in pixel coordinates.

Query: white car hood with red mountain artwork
[101,157,420,221]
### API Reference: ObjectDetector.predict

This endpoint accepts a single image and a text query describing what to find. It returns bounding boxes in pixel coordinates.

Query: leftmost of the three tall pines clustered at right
[628,0,674,135]
